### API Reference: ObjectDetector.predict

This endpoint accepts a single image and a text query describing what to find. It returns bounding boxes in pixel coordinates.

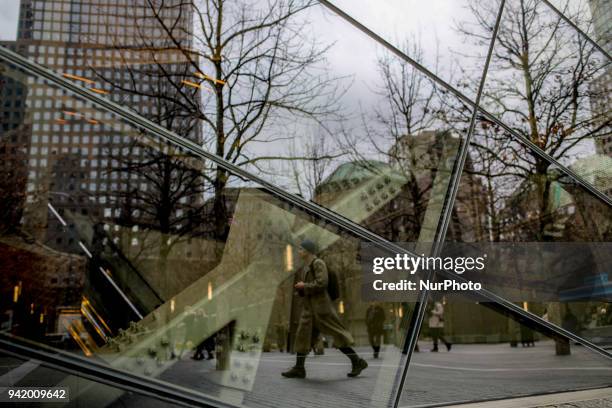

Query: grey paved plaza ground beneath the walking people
[0,342,612,408]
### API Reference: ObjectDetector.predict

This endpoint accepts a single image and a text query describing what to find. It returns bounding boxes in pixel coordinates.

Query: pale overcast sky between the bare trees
[0,0,596,192]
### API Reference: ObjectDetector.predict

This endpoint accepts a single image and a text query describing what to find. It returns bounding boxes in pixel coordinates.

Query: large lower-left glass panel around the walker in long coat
[0,60,418,406]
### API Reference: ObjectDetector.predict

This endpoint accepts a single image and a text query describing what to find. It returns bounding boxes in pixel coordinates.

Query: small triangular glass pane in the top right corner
[549,0,612,58]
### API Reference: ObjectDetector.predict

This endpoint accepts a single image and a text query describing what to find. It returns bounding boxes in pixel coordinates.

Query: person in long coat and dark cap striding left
[282,240,368,378]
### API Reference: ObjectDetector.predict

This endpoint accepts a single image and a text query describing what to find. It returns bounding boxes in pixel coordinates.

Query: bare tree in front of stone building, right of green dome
[354,38,478,241]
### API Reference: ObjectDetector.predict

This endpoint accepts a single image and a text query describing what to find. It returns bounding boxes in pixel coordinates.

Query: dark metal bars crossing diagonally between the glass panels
[0,0,612,406]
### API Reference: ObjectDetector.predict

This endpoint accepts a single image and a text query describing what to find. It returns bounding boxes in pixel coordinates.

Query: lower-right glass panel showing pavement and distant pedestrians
[401,295,612,406]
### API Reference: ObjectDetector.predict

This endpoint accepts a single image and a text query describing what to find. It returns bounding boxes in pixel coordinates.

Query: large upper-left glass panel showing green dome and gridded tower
[0,1,474,242]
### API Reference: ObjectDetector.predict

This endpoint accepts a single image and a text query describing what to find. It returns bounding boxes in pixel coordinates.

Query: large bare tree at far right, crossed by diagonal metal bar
[458,0,610,240]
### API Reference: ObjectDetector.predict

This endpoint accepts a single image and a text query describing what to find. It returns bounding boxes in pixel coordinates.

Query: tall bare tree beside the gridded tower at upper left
[94,0,339,244]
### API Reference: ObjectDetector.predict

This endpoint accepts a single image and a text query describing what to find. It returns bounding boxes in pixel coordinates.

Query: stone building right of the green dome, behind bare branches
[388,131,486,242]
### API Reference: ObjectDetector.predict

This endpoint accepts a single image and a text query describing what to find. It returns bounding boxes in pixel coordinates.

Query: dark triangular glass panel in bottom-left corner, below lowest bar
[0,354,179,408]
